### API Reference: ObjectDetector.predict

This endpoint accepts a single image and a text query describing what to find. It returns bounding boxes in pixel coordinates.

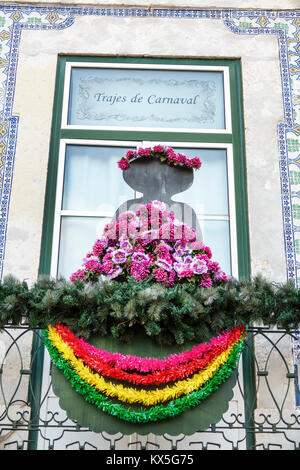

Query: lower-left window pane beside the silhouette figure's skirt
[57,217,111,279]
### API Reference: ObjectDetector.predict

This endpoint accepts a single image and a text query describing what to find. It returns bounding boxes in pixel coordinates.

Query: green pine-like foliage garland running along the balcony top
[0,276,300,344]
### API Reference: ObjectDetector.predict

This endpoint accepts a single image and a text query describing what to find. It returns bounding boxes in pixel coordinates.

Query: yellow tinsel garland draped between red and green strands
[48,326,244,406]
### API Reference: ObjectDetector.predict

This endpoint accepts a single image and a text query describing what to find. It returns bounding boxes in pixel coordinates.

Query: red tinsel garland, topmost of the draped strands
[55,324,245,385]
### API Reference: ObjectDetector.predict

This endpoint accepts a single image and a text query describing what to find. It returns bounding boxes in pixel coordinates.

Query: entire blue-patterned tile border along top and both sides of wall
[0,5,300,284]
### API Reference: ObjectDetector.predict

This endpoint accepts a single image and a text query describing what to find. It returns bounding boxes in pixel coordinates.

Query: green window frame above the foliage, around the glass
[39,56,250,278]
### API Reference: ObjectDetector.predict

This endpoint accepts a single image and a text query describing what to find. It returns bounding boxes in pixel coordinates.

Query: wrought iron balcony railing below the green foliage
[0,325,300,451]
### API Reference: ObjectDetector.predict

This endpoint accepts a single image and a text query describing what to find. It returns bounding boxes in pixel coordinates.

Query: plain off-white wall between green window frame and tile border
[4,12,285,280]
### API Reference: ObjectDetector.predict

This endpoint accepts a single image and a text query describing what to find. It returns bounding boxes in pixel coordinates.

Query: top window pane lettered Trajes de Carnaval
[68,67,225,129]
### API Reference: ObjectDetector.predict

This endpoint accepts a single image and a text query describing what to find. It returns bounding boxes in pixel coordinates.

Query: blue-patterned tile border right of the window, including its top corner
[224,11,300,285]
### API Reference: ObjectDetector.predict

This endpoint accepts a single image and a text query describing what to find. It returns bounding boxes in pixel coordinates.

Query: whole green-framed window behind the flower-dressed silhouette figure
[40,57,249,277]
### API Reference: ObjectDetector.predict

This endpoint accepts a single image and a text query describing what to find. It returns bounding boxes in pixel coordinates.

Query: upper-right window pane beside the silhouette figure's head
[172,148,229,216]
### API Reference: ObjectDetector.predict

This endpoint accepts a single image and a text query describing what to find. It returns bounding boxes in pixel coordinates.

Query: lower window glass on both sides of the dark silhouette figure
[58,145,231,277]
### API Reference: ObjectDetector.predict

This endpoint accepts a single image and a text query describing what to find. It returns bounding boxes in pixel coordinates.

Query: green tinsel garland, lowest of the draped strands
[44,330,245,423]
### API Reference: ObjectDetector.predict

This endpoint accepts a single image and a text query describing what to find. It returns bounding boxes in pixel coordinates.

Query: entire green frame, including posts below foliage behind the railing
[29,56,255,450]
